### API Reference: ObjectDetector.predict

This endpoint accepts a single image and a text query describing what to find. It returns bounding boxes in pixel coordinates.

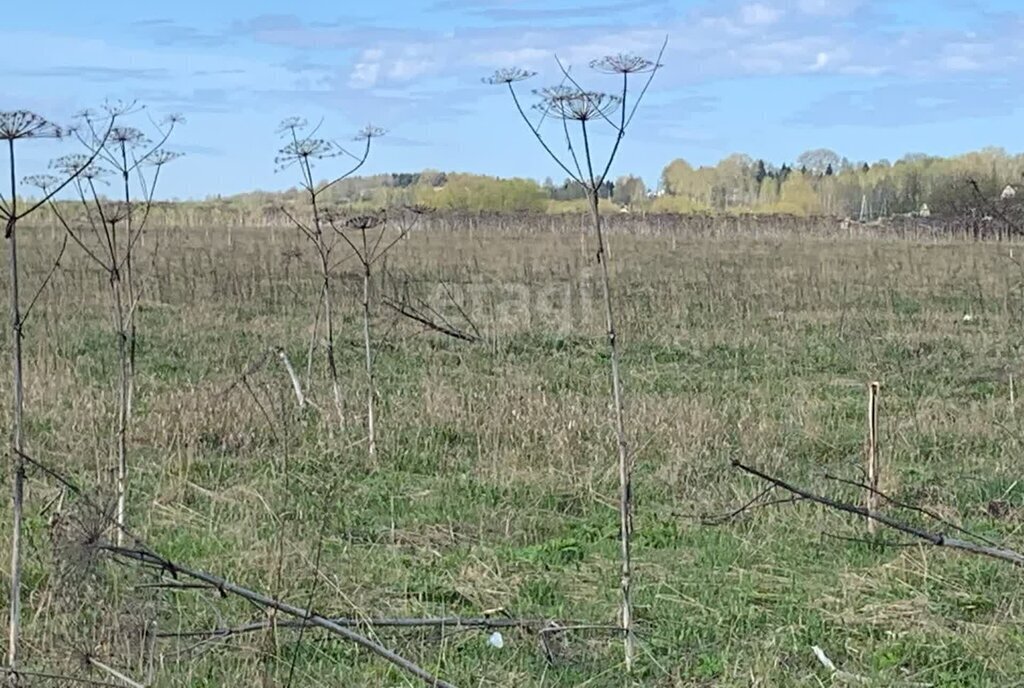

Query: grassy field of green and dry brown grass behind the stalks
[0,223,1024,687]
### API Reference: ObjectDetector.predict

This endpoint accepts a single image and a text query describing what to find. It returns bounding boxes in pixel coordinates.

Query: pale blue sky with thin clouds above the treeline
[0,0,1024,198]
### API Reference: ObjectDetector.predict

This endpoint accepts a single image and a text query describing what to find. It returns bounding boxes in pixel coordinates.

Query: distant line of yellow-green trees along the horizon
[188,148,1024,220]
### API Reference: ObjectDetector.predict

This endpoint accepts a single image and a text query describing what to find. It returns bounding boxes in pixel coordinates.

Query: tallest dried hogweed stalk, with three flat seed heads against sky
[484,41,668,671]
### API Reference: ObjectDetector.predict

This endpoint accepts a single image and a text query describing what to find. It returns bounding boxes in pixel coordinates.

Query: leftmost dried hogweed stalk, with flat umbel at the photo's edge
[0,109,119,669]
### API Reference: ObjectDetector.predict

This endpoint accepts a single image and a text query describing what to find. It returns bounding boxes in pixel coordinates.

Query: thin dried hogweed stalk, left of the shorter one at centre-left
[274,117,384,426]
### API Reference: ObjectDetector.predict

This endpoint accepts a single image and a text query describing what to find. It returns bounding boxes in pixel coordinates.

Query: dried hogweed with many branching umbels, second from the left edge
[43,107,183,542]
